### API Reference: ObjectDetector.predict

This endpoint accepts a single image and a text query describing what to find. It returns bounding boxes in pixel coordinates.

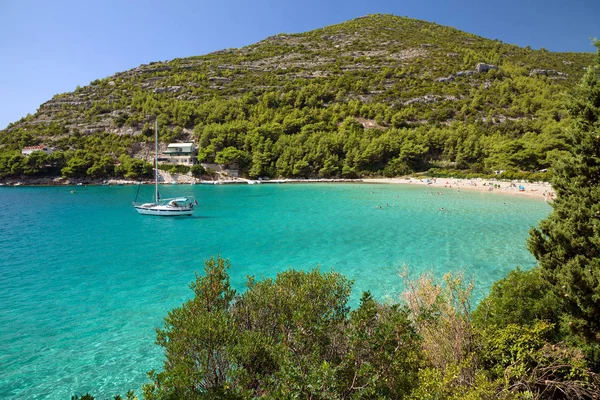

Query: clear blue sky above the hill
[0,0,600,129]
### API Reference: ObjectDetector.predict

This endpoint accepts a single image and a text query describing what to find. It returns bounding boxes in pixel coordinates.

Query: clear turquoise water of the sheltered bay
[0,184,550,399]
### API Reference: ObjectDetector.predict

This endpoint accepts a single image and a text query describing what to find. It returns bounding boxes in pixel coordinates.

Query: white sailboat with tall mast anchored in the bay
[132,121,198,217]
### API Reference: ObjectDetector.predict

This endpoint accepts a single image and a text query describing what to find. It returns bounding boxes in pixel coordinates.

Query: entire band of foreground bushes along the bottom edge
[78,257,600,400]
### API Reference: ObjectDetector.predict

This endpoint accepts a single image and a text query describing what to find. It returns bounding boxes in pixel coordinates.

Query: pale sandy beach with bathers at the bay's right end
[362,178,555,200]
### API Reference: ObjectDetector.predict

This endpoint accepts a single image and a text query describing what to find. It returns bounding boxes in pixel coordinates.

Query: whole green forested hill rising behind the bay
[0,15,594,178]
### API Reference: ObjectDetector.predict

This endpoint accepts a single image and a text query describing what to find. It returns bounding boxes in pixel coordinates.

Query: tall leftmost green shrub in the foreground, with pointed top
[144,257,235,399]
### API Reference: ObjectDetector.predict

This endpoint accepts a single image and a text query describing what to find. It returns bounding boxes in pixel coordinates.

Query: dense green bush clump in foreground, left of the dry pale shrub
[144,258,422,399]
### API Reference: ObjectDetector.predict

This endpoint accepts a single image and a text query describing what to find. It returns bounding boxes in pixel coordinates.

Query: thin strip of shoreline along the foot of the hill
[0,176,555,201]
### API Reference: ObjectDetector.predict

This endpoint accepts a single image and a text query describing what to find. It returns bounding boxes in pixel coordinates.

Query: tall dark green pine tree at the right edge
[528,41,600,340]
